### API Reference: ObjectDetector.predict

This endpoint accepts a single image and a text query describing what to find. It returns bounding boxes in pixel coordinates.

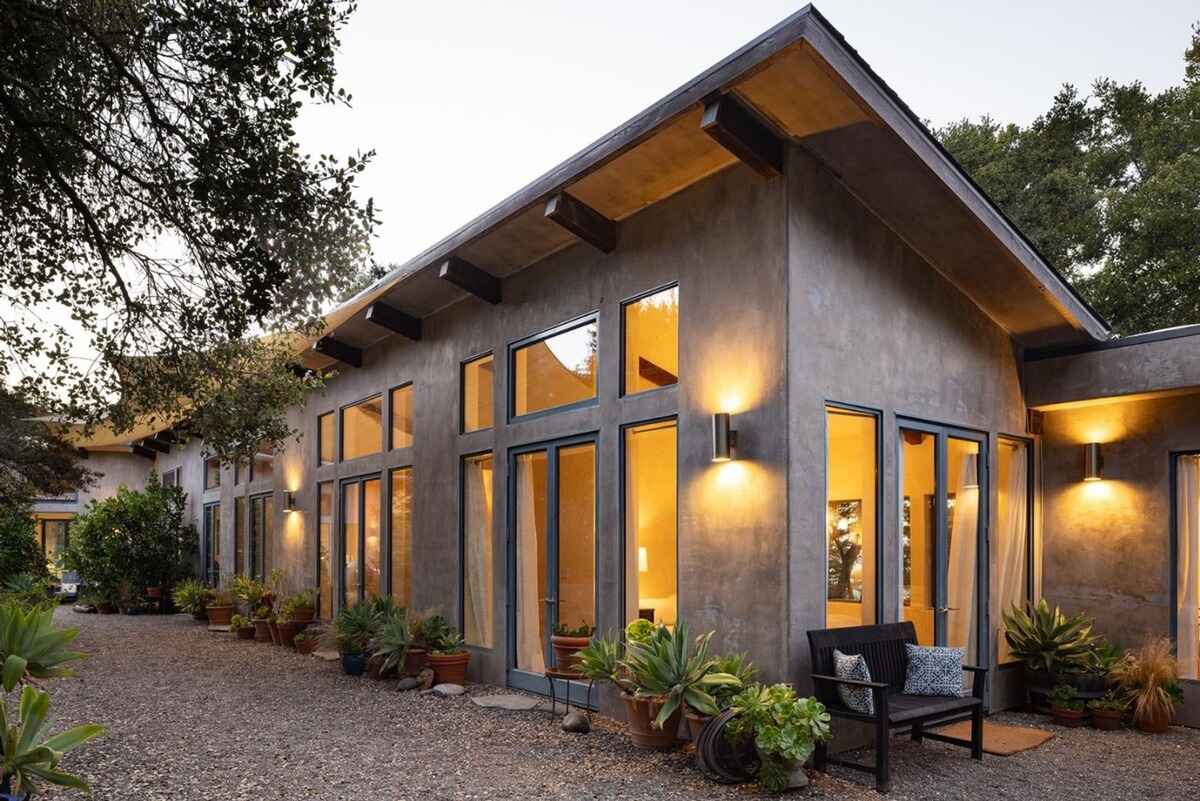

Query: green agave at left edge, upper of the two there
[0,602,83,692]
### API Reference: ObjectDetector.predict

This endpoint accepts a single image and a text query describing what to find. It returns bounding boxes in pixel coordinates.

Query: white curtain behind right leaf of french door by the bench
[947,453,980,664]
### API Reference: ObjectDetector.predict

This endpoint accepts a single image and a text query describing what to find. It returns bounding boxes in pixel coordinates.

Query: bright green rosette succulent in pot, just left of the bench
[726,685,832,793]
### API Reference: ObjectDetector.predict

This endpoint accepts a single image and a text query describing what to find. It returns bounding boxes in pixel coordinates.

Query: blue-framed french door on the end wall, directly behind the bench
[898,420,989,664]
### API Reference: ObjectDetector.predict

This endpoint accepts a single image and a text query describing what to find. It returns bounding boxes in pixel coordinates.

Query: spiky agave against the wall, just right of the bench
[1003,598,1098,673]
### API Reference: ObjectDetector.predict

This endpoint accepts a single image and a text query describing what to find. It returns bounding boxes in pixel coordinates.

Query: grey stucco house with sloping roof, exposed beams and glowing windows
[54,6,1200,722]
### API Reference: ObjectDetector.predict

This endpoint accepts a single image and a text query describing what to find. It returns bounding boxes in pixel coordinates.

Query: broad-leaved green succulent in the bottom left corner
[0,685,104,795]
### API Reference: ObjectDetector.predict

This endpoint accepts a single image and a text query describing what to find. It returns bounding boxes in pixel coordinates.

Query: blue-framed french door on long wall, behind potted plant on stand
[509,435,596,692]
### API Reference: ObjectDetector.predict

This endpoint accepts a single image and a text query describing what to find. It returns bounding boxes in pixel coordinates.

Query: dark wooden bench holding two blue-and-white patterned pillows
[809,621,988,793]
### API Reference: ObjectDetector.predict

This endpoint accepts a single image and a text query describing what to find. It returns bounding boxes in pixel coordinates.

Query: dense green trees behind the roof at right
[936,24,1200,335]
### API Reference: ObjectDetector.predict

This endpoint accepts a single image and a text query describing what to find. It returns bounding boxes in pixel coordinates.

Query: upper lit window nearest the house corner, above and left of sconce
[623,287,679,395]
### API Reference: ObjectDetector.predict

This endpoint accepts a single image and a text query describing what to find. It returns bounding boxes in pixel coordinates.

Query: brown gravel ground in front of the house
[42,608,1200,801]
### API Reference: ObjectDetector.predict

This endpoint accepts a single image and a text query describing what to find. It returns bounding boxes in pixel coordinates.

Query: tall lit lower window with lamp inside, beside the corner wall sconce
[625,420,679,624]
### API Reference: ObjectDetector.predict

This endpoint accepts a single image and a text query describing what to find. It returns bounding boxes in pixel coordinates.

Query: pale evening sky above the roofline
[298,0,1200,264]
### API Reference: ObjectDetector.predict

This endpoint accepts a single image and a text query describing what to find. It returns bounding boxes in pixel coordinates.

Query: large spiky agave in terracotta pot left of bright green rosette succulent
[622,622,740,729]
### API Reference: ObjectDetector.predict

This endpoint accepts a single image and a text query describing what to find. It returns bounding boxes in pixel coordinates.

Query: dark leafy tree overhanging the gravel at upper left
[0,0,377,456]
